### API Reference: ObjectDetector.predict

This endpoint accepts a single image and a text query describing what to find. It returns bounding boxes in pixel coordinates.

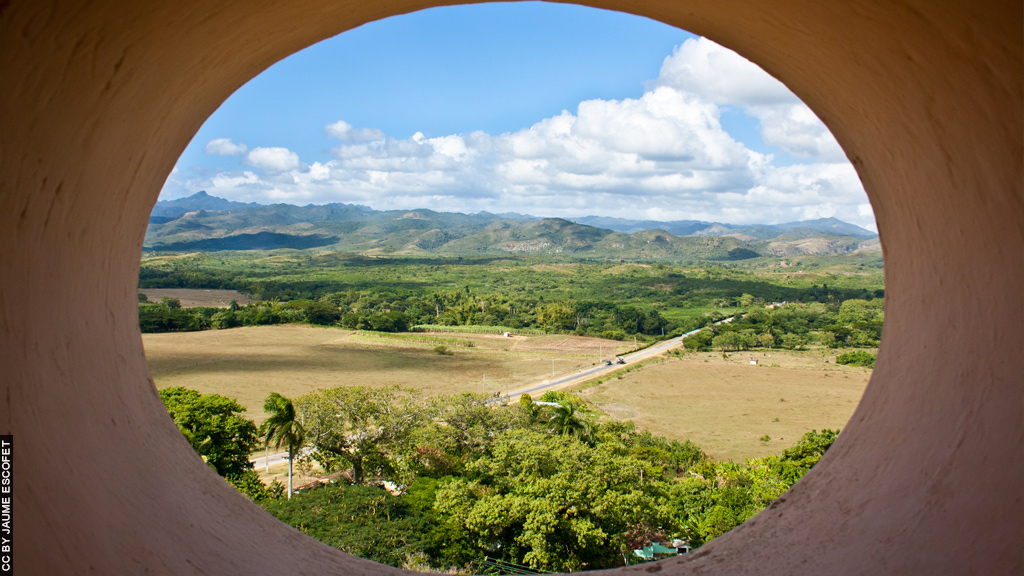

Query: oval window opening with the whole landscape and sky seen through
[139,4,884,572]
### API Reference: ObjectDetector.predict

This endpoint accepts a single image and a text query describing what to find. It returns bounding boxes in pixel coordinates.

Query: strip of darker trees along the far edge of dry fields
[138,290,885,352]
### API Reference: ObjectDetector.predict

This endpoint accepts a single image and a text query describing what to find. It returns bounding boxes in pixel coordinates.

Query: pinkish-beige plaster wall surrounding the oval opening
[0,0,1024,574]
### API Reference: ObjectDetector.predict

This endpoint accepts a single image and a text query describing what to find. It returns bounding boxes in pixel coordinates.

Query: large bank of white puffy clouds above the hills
[167,39,874,229]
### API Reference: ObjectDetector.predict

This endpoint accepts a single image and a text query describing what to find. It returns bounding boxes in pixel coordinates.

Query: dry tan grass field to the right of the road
[581,351,870,460]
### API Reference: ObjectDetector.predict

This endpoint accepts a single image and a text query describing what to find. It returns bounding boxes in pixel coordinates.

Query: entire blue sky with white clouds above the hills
[161,2,874,230]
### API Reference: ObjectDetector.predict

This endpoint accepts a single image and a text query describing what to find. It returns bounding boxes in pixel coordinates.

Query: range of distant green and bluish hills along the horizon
[144,192,879,260]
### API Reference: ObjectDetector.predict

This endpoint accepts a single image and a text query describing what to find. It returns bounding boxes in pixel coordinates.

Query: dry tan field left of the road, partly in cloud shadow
[142,325,632,423]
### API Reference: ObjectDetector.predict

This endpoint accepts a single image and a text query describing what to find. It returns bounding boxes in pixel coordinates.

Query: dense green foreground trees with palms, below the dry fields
[161,386,839,572]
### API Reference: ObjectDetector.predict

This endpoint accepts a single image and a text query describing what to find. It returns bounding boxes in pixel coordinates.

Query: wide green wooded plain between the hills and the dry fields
[139,253,885,344]
